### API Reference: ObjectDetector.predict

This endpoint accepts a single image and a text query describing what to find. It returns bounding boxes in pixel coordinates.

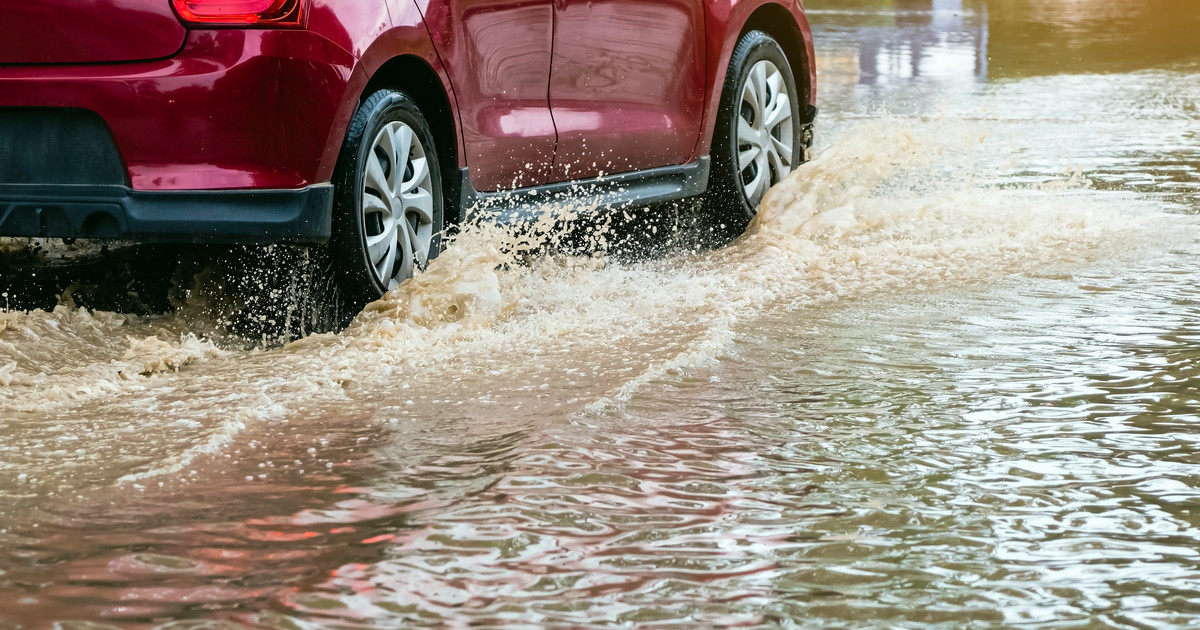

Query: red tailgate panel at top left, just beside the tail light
[0,0,187,64]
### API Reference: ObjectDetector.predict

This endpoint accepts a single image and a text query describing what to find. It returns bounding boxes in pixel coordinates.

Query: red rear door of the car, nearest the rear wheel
[416,0,556,191]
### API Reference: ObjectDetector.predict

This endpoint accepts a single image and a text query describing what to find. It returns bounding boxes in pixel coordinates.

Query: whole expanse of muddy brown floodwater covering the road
[0,0,1200,630]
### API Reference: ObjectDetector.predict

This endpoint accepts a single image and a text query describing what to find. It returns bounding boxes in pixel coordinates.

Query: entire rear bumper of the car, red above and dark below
[0,29,354,244]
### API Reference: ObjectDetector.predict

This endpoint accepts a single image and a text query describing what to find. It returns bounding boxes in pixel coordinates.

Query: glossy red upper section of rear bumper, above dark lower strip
[0,29,355,191]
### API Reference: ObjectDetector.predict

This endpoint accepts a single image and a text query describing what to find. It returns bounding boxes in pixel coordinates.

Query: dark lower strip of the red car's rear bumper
[0,184,334,244]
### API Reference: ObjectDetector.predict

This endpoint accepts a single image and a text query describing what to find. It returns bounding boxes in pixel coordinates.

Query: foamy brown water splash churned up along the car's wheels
[0,120,1163,499]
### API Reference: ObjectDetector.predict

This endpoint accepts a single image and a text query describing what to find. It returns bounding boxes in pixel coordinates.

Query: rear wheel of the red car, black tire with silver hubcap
[330,89,444,307]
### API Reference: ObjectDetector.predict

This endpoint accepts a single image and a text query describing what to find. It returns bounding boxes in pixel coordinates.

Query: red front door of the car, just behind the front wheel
[550,0,704,181]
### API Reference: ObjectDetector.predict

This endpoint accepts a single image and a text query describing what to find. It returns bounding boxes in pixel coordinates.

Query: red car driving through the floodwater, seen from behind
[0,0,816,301]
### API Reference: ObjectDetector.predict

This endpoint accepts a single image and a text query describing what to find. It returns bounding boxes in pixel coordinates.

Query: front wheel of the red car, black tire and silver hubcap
[706,30,804,240]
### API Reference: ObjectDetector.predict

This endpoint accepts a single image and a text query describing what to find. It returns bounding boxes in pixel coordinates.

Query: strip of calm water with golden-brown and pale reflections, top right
[805,0,1200,85]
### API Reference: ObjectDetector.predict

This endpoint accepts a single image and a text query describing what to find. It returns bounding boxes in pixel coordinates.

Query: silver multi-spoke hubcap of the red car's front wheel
[737,60,796,209]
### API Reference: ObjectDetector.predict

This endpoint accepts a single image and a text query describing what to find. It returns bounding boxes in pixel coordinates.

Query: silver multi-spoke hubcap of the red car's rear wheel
[361,122,433,290]
